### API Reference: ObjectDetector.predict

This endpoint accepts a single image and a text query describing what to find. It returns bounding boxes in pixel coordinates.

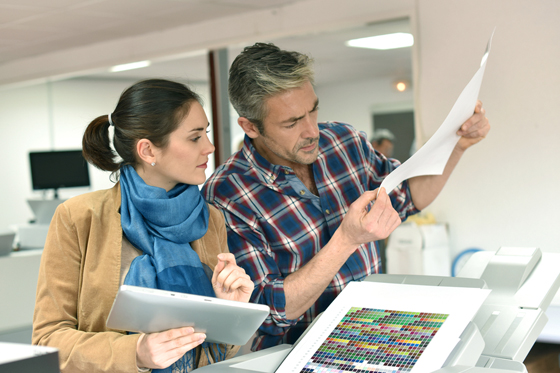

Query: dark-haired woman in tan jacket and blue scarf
[33,80,253,373]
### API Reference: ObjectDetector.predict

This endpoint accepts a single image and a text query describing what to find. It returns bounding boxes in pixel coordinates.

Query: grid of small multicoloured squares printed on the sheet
[301,307,448,373]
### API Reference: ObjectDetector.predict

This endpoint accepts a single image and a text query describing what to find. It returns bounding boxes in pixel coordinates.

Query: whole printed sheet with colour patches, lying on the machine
[276,281,490,373]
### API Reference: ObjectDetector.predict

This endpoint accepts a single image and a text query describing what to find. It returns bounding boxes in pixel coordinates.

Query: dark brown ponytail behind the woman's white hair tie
[82,115,120,172]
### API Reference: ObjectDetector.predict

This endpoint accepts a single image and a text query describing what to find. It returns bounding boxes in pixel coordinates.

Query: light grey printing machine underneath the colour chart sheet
[197,247,560,373]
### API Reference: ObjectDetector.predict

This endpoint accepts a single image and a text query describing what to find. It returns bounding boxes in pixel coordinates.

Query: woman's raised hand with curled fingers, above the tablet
[212,253,254,302]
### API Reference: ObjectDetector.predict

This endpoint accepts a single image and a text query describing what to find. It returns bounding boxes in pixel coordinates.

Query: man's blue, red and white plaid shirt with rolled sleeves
[202,122,418,350]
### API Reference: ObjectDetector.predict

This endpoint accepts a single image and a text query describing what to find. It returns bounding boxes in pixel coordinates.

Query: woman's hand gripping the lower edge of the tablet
[136,326,206,369]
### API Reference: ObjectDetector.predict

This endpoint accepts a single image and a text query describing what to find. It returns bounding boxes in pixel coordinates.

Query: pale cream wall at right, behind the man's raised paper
[416,0,560,253]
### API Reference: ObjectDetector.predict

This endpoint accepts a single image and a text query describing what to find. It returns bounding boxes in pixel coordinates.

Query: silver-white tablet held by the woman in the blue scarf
[107,285,270,346]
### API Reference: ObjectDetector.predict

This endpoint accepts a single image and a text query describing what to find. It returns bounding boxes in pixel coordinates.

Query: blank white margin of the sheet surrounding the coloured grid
[276,282,490,373]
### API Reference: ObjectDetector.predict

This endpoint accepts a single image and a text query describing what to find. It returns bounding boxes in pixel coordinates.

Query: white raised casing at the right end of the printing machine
[452,247,560,372]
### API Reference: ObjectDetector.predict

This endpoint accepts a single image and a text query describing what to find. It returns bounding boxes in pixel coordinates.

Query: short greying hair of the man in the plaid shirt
[228,43,313,134]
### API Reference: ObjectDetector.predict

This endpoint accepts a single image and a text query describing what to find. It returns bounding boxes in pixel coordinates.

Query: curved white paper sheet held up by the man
[381,33,494,193]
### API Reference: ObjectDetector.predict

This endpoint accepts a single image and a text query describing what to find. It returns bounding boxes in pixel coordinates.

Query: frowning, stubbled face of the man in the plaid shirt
[249,82,319,168]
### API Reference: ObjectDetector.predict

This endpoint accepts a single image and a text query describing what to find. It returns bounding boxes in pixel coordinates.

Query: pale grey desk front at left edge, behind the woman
[0,249,43,343]
